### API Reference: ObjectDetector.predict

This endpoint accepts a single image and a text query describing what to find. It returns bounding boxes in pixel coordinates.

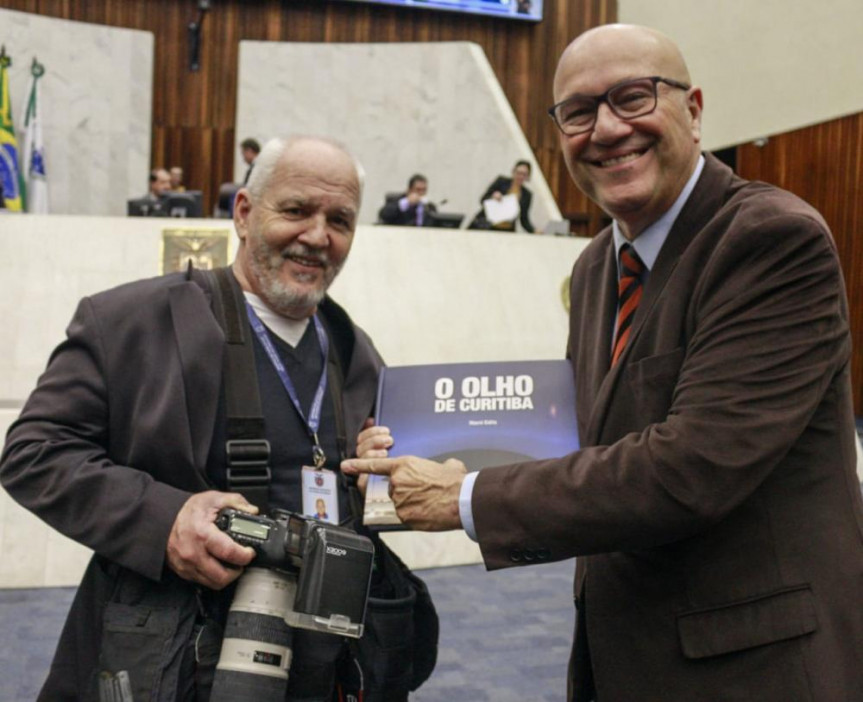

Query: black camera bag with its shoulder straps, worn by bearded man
[197,268,439,702]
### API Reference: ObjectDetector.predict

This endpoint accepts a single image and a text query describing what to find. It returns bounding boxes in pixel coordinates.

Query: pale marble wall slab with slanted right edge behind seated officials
[235,41,560,231]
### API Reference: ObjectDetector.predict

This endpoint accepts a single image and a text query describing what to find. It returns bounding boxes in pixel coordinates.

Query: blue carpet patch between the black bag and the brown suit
[411,561,575,702]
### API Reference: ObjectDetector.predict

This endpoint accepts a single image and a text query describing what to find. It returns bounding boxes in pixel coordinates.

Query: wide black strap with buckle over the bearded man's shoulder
[201,268,271,514]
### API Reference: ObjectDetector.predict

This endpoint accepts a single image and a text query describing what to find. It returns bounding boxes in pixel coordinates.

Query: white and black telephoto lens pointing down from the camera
[210,568,297,702]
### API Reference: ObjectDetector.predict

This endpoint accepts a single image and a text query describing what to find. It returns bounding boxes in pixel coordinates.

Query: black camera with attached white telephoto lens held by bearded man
[211,509,374,702]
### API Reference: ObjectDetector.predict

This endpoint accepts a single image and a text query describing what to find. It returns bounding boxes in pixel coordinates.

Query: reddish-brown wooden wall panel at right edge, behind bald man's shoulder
[737,113,863,416]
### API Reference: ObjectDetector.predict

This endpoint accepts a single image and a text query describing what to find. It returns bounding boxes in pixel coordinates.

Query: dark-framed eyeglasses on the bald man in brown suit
[548,76,690,136]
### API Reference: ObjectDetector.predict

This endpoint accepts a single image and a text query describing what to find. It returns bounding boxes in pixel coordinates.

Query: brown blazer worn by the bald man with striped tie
[473,156,863,702]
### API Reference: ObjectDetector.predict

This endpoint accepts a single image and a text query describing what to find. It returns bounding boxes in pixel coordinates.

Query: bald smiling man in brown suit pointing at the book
[343,25,863,702]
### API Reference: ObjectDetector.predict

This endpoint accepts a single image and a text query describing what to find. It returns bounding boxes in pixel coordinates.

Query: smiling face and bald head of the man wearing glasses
[554,25,702,240]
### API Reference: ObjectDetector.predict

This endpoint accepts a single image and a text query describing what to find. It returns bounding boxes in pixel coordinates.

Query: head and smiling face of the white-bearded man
[234,139,360,319]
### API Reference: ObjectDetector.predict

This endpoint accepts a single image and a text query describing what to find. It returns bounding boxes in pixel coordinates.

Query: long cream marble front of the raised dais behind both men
[0,215,587,587]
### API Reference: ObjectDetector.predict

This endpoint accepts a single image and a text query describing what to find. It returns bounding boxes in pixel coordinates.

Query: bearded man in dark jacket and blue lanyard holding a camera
[0,137,432,702]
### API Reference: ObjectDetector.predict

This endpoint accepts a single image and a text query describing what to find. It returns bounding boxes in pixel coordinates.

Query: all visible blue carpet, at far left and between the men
[0,561,574,702]
